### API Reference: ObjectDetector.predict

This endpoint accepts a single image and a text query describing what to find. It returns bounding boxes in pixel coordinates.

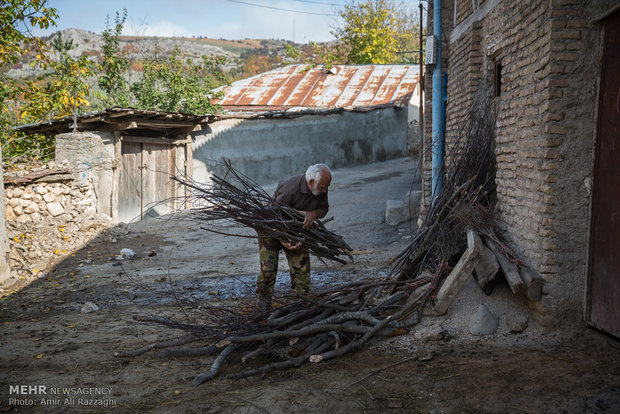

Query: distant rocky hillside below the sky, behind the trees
[5,29,298,79]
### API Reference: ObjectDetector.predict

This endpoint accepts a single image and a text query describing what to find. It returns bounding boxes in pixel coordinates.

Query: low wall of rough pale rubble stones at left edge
[4,163,112,282]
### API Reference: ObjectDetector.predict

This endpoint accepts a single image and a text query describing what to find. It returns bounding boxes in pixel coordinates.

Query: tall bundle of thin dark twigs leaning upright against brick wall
[391,90,495,287]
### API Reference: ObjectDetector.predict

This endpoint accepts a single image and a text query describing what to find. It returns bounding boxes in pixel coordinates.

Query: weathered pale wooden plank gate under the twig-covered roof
[118,137,175,222]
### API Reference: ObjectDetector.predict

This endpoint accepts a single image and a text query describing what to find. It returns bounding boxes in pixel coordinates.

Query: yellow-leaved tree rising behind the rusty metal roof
[331,0,413,64]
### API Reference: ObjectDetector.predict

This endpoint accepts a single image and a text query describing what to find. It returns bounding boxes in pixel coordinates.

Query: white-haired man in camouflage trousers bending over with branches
[256,164,332,309]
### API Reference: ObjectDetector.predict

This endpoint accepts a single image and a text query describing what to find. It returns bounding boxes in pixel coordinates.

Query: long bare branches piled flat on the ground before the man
[115,279,429,386]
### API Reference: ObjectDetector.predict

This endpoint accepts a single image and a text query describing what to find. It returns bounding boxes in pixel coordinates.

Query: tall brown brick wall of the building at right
[423,0,614,325]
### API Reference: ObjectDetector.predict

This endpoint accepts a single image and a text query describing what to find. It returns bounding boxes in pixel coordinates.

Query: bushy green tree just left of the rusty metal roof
[131,48,226,114]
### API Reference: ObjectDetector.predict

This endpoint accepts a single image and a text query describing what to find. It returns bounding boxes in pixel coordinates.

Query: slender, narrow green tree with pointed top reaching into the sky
[98,9,130,107]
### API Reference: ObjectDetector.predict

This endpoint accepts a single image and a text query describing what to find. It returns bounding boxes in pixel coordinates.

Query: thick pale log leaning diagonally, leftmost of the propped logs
[433,229,482,315]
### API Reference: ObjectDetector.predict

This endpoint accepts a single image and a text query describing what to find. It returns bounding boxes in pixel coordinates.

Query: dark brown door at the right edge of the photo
[586,13,620,337]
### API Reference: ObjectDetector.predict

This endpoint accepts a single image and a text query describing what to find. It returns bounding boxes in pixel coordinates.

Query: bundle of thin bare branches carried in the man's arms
[173,160,353,263]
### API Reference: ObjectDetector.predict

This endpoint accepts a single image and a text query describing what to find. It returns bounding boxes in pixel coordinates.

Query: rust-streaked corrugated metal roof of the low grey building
[214,65,420,110]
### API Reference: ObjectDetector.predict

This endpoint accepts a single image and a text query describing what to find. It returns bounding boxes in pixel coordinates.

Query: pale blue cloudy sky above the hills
[35,0,358,43]
